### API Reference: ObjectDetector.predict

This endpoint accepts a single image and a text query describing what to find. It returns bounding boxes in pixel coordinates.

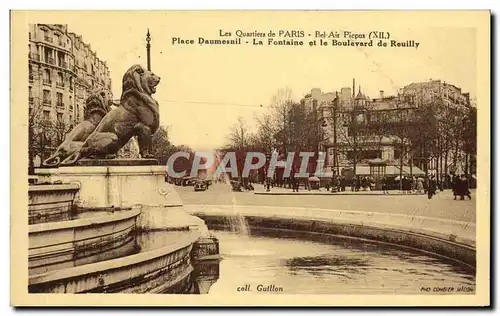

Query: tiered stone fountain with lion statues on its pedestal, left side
[28,65,219,293]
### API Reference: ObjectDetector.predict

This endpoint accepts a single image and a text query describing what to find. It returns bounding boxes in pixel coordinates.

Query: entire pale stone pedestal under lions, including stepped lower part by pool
[36,159,208,232]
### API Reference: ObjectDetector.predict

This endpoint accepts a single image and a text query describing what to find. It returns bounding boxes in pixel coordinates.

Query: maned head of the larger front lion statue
[122,65,160,99]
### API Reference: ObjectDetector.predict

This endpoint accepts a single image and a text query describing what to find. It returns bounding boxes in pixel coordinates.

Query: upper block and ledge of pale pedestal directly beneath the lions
[36,159,176,207]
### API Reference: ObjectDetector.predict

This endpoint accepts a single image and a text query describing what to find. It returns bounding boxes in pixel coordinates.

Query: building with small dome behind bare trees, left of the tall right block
[319,87,411,167]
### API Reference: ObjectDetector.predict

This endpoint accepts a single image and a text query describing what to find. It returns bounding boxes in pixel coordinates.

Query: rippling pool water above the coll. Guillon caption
[209,227,476,296]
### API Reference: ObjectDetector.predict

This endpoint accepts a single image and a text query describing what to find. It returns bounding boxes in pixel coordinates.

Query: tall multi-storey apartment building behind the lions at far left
[28,24,112,165]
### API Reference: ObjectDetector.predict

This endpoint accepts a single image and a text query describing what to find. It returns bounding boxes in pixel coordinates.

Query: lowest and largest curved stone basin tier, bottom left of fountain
[28,232,199,293]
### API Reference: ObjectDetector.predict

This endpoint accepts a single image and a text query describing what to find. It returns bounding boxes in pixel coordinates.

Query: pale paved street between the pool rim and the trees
[175,184,476,222]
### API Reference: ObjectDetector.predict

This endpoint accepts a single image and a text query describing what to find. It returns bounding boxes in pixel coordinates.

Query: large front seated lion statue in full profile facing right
[62,65,160,165]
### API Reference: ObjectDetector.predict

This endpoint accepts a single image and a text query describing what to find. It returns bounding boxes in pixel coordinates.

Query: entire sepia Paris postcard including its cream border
[11,11,490,306]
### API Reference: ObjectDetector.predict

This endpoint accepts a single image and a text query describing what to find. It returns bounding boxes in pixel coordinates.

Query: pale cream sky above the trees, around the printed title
[59,11,477,150]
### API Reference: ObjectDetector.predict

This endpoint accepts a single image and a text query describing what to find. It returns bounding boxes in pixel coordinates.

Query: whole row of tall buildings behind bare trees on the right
[317,80,472,181]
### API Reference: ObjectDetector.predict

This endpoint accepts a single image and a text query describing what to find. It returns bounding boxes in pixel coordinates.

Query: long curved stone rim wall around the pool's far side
[185,205,476,268]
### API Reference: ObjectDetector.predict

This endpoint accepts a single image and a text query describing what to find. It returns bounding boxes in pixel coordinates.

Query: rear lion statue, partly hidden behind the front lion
[43,90,111,167]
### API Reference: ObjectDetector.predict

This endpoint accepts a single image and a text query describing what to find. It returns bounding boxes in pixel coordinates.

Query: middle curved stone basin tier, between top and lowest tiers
[28,210,140,275]
